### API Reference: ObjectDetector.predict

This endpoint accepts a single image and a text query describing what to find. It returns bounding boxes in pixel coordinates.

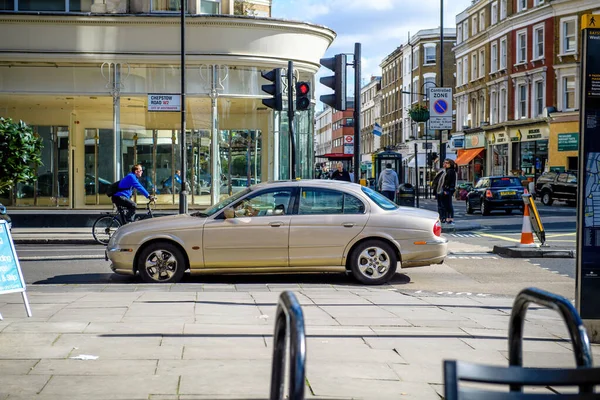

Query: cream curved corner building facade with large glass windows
[0,0,335,208]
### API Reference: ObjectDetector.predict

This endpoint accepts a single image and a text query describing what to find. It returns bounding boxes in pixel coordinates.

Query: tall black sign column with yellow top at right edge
[576,14,600,343]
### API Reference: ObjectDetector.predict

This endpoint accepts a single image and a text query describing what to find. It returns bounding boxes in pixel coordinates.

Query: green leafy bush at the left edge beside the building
[0,118,43,193]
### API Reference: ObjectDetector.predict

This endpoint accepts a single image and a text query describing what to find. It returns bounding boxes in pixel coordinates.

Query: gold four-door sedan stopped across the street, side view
[106,180,447,285]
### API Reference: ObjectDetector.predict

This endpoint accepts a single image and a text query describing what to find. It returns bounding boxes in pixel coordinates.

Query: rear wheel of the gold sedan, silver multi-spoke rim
[350,240,398,285]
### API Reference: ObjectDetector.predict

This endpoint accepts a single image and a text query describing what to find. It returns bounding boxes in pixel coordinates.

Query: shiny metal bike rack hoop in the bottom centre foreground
[270,291,306,400]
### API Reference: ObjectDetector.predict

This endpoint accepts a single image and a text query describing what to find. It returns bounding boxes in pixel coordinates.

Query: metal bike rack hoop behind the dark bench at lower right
[508,288,593,393]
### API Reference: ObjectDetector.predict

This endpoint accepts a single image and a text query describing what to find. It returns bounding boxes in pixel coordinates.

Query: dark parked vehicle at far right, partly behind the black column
[535,171,577,206]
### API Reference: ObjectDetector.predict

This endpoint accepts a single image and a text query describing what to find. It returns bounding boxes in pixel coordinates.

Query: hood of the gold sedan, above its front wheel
[109,214,206,246]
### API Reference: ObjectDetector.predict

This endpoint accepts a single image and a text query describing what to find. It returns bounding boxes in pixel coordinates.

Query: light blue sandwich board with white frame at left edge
[0,220,31,320]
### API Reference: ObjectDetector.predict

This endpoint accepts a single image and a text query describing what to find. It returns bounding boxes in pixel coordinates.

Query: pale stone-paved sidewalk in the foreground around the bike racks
[0,284,600,400]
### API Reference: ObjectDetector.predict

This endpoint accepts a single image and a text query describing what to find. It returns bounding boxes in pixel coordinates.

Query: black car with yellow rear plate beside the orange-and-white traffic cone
[466,176,524,215]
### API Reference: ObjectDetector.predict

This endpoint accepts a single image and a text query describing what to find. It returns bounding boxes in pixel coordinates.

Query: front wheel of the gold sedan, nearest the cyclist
[138,242,185,283]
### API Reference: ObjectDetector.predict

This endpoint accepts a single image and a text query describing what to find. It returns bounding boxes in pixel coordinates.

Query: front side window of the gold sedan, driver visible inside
[233,188,292,217]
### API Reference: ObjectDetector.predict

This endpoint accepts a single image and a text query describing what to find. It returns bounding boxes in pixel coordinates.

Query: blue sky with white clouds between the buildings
[271,0,472,109]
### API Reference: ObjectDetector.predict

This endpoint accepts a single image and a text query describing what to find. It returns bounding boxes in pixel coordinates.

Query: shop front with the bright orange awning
[455,132,486,183]
